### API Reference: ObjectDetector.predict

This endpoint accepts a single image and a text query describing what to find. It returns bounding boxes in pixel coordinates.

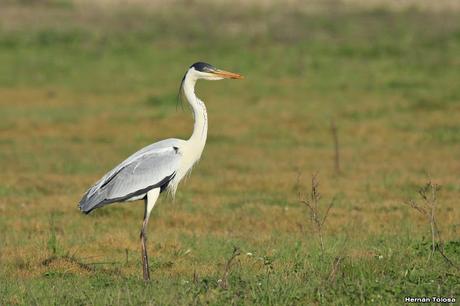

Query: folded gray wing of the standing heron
[79,139,183,213]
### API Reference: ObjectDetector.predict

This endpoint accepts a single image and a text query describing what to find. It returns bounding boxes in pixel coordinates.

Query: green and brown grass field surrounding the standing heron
[0,0,460,305]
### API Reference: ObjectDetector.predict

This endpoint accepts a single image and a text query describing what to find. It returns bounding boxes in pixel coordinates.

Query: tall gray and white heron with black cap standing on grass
[78,62,244,281]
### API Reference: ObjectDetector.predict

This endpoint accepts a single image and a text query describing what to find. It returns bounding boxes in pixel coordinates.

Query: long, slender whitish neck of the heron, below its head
[183,74,208,151]
